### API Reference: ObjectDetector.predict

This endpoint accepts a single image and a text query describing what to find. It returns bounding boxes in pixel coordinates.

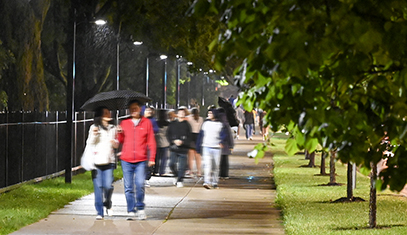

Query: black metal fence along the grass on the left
[0,112,101,188]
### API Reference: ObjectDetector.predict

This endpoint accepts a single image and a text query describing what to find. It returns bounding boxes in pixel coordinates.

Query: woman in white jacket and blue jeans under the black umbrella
[86,107,119,220]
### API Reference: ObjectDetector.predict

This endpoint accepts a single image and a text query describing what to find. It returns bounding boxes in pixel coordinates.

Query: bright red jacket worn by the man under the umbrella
[117,117,156,163]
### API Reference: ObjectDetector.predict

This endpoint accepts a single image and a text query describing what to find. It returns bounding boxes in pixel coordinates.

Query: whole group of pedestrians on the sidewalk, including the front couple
[87,100,234,220]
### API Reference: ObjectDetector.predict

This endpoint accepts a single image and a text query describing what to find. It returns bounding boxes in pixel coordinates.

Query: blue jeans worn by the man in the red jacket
[122,160,147,212]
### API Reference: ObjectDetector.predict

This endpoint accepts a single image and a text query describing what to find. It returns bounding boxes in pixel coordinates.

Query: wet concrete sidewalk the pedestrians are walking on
[12,136,284,235]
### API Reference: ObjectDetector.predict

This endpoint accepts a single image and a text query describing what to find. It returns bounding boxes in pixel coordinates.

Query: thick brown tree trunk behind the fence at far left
[0,0,50,111]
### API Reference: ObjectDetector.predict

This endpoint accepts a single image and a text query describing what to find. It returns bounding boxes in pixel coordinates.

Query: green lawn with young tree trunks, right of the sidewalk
[271,138,407,235]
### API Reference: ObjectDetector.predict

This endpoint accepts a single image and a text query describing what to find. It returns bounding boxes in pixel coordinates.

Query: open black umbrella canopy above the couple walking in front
[81,90,151,111]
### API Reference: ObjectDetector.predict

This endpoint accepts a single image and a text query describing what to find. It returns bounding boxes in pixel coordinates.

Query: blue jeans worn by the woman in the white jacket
[92,164,113,216]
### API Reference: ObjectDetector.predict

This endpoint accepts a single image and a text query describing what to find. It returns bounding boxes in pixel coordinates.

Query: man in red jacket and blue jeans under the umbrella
[117,100,156,220]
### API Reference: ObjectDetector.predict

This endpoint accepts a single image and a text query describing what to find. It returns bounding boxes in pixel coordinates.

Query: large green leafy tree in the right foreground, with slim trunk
[195,0,407,227]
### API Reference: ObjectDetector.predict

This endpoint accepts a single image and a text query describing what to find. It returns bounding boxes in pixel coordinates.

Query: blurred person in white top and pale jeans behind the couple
[196,108,226,189]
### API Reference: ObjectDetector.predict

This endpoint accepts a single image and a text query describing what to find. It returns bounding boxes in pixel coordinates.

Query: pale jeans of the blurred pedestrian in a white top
[202,147,221,186]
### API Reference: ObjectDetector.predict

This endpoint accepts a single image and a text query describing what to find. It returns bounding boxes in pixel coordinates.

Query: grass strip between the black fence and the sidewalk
[0,166,122,235]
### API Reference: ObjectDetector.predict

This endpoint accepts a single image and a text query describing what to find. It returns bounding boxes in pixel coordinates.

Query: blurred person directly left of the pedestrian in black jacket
[154,110,170,176]
